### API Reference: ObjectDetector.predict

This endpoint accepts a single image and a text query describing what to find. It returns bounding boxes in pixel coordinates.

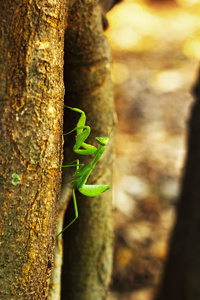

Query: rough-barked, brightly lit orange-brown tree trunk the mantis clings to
[0,0,65,300]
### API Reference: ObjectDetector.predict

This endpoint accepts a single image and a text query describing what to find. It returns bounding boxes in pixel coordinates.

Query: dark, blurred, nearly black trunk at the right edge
[156,71,200,300]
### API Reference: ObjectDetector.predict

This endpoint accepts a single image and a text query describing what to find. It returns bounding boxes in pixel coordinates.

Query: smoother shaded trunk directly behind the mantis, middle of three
[50,0,115,300]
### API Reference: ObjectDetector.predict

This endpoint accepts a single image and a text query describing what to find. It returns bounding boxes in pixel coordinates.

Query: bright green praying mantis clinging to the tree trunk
[56,106,110,239]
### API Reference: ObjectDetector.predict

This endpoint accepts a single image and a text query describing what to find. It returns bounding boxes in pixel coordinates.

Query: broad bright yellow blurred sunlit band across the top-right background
[106,0,200,58]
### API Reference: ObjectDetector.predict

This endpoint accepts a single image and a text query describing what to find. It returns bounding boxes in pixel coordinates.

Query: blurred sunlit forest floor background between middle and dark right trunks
[105,0,200,300]
